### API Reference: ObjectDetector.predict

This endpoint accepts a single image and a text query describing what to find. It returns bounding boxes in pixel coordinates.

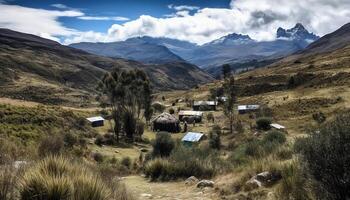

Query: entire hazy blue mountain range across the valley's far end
[70,23,319,75]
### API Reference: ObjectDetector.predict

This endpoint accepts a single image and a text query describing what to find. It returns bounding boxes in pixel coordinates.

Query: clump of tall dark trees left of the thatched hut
[99,68,152,142]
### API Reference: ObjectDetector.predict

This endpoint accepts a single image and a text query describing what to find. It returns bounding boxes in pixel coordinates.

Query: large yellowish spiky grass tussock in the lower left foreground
[19,157,112,200]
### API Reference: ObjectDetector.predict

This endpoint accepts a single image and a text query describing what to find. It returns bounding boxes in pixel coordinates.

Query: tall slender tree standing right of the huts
[223,76,236,134]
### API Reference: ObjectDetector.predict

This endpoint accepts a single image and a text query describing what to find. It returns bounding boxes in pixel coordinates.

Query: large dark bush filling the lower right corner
[299,112,350,199]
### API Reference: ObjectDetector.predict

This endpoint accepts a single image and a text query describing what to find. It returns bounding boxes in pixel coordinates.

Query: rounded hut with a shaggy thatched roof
[151,112,181,133]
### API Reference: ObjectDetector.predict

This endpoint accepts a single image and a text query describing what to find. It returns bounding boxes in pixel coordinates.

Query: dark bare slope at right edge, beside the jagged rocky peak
[301,23,350,53]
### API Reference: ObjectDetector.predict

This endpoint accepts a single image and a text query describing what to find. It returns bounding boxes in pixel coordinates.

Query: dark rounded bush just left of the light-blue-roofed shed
[152,132,175,157]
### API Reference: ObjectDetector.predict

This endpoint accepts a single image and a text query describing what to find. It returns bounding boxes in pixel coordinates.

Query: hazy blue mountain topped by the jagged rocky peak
[190,24,318,71]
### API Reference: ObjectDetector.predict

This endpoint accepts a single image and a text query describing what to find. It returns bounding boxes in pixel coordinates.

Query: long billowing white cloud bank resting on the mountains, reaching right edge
[65,0,350,44]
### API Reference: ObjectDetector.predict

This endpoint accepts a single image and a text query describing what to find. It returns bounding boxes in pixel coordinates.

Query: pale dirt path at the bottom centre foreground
[123,176,219,200]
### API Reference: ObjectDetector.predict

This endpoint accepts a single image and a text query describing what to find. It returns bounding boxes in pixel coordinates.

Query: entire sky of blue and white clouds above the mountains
[0,0,350,44]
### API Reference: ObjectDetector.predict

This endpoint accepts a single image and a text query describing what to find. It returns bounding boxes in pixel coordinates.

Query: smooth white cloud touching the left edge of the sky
[0,4,84,40]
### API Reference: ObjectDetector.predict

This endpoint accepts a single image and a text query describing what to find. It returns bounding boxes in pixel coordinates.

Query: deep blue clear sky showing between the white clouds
[4,0,230,32]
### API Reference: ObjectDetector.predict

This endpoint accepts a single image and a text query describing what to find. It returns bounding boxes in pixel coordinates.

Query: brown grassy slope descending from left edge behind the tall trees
[0,29,213,105]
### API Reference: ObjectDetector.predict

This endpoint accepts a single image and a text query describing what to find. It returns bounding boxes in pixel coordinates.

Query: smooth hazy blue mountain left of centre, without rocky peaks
[69,37,185,64]
